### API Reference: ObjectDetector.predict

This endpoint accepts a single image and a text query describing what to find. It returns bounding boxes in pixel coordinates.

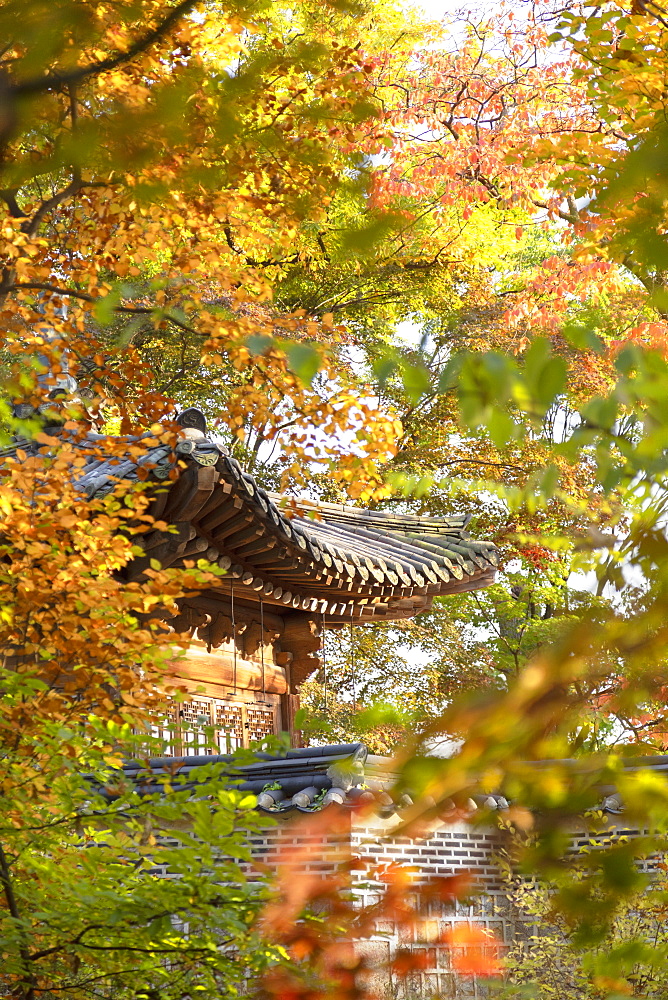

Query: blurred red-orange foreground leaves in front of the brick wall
[261,809,501,1000]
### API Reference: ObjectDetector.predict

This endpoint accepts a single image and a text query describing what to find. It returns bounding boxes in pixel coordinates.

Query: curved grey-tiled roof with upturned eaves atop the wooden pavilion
[4,410,498,624]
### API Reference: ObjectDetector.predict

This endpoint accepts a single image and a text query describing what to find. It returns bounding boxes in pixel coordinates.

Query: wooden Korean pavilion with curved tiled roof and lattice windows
[5,409,497,756]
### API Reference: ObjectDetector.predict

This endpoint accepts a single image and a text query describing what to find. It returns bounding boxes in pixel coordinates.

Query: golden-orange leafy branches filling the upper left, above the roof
[0,3,396,496]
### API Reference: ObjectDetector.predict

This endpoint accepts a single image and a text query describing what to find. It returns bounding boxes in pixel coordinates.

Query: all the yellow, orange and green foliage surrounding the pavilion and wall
[5,0,668,1000]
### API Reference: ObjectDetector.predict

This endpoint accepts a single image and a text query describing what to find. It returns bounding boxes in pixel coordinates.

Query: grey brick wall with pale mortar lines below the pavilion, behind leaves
[151,805,660,1000]
